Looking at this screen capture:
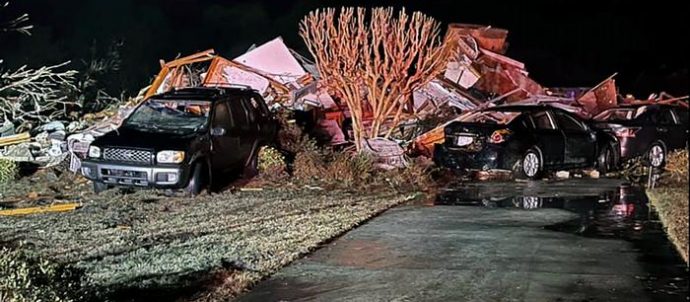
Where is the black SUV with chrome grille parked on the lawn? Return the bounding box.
[81,88,278,195]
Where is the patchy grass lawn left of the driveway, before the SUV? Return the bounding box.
[0,169,413,300]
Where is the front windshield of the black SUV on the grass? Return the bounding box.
[123,99,211,133]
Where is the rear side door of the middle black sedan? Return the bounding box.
[530,110,565,166]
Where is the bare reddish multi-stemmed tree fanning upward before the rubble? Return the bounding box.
[300,8,453,148]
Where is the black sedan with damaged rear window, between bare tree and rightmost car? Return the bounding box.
[434,105,619,179]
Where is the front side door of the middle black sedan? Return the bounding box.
[551,109,597,166]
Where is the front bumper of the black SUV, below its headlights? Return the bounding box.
[80,161,187,188]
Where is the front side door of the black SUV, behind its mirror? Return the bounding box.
[211,101,240,172]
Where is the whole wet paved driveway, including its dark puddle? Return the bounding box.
[239,179,688,301]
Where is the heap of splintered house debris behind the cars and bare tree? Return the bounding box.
[0,24,687,180]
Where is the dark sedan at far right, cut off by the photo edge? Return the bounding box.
[594,104,688,168]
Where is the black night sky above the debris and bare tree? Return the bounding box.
[0,0,690,97]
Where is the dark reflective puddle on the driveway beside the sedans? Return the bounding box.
[434,182,688,301]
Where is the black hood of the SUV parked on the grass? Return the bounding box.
[92,127,199,151]
